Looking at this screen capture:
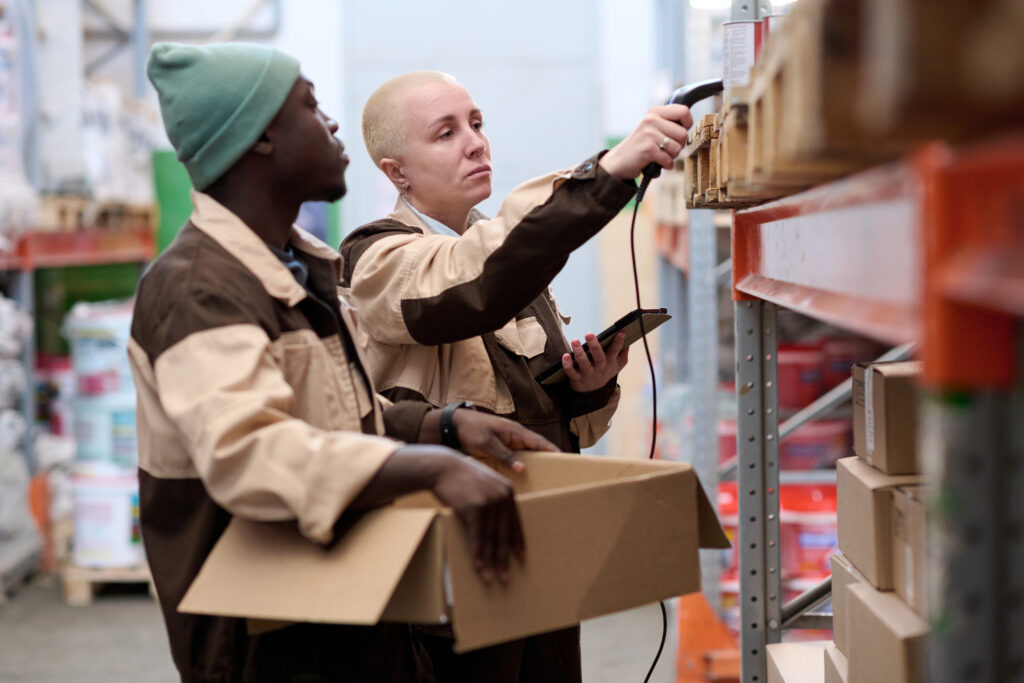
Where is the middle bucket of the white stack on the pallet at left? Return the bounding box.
[72,393,138,467]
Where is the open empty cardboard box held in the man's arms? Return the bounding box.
[179,454,729,651]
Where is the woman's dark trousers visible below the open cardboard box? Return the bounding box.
[417,626,583,683]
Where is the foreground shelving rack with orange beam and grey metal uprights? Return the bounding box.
[732,136,1024,683]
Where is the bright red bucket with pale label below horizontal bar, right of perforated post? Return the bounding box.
[779,483,838,579]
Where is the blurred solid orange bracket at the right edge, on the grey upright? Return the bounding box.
[912,139,1024,390]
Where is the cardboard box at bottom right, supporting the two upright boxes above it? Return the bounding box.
[848,584,929,683]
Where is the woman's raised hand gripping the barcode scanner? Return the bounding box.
[598,104,693,180]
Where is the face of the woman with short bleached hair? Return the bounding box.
[399,82,490,220]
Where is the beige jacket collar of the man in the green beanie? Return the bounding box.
[189,190,341,306]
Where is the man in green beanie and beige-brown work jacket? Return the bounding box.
[129,43,555,683]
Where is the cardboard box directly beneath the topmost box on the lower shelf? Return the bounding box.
[836,458,922,591]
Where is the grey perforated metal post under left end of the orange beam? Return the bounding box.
[735,301,782,683]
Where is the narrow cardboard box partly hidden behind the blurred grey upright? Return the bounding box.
[893,486,928,618]
